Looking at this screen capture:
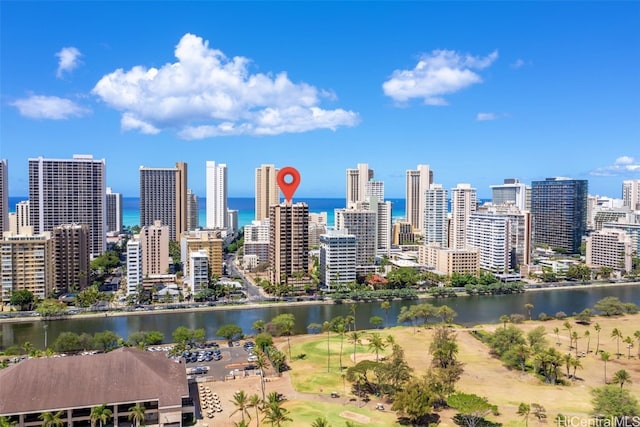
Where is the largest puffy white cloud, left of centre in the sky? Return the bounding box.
[92,34,359,139]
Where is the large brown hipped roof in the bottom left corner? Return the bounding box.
[0,348,189,415]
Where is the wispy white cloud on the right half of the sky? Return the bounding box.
[382,50,498,105]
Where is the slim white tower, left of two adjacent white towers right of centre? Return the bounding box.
[421,184,448,247]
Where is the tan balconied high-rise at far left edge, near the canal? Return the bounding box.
[0,227,54,304]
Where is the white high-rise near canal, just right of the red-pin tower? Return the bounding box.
[320,230,357,292]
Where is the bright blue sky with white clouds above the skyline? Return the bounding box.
[0,1,640,197]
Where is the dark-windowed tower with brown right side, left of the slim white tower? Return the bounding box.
[140,162,187,241]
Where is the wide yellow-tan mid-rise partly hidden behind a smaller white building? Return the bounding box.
[180,230,224,277]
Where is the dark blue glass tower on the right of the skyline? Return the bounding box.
[531,178,588,253]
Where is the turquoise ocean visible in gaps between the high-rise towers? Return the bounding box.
[9,196,405,231]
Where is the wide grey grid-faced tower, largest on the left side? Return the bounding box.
[29,155,107,256]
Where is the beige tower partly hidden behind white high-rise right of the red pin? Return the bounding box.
[335,208,378,267]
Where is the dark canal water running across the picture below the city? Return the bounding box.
[0,285,640,348]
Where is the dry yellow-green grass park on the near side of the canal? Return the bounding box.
[199,315,640,427]
